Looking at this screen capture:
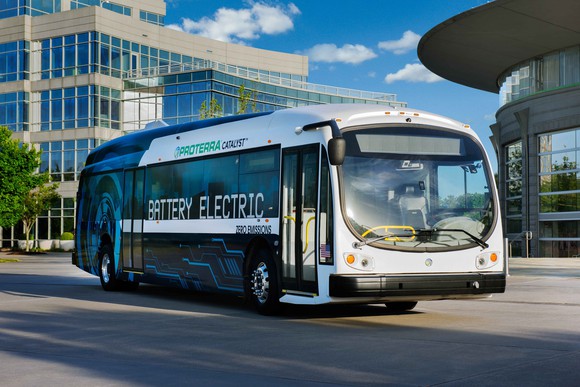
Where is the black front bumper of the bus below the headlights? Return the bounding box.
[329,273,506,297]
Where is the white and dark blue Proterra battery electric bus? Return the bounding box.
[73,104,506,314]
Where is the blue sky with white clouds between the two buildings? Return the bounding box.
[165,0,499,170]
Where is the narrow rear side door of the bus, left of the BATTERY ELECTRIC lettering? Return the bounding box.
[122,168,145,272]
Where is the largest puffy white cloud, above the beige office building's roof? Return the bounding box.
[167,2,300,43]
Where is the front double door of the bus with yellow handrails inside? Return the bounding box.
[281,145,319,296]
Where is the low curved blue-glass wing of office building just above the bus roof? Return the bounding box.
[123,70,401,131]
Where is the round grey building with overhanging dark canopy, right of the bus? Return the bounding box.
[418,0,580,257]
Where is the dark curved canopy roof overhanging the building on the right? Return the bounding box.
[417,0,580,93]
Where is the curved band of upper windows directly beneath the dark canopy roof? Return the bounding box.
[499,46,580,106]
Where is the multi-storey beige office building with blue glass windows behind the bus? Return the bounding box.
[0,0,405,246]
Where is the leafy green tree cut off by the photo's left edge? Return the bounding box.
[0,127,49,227]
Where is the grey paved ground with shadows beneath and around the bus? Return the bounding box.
[0,253,580,386]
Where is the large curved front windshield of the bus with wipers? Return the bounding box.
[341,127,495,251]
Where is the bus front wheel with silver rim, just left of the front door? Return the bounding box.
[246,250,280,316]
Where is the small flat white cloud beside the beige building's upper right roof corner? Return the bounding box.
[302,43,377,64]
